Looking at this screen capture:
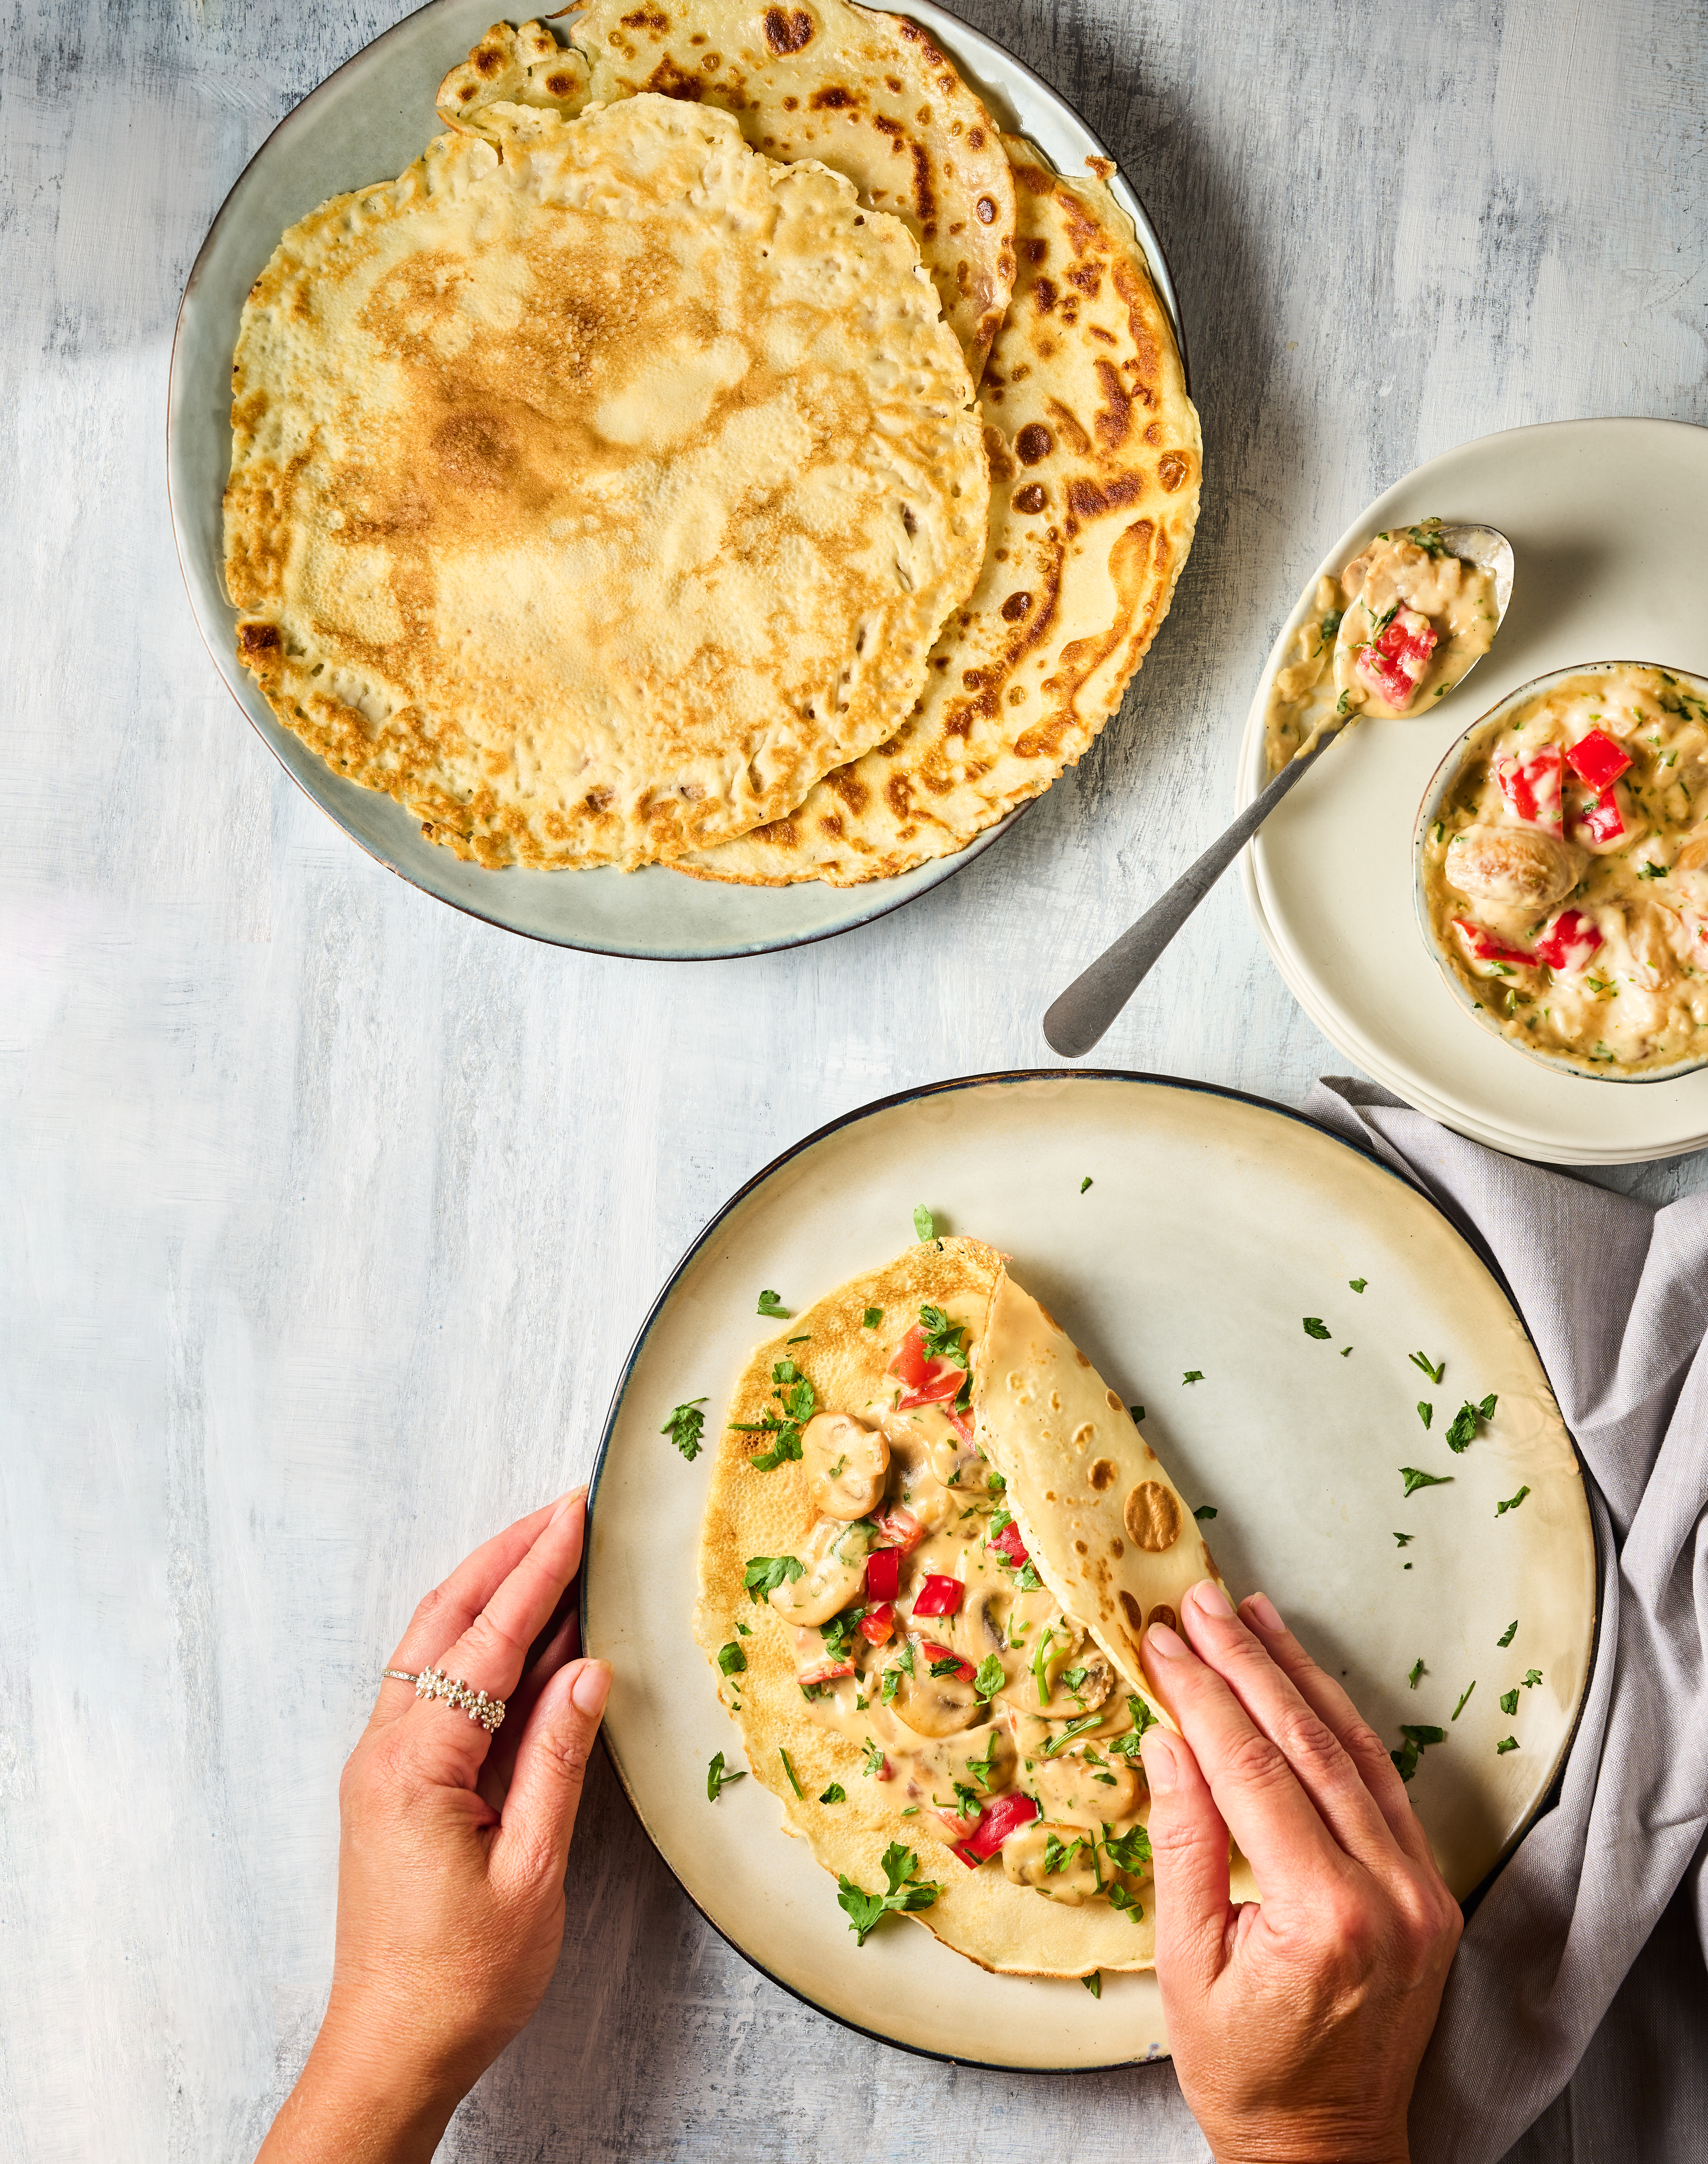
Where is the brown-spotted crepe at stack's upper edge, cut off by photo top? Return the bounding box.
[437,0,1015,383]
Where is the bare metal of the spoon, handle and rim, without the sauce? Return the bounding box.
[1044,526,1513,1060]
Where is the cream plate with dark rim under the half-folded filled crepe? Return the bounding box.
[582,1071,1595,2071]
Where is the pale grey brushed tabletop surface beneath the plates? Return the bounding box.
[0,0,1708,2164]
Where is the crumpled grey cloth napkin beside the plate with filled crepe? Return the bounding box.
[1305,1075,1708,2164]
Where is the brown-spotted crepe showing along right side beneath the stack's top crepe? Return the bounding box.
[677,136,1201,887]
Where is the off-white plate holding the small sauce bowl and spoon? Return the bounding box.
[1240,420,1708,1164]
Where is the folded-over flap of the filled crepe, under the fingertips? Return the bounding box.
[974,1270,1221,1727]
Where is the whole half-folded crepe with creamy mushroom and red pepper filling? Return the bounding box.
[697,1240,1238,1976]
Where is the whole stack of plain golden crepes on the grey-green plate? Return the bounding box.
[225,0,1199,885]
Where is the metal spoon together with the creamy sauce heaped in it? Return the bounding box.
[1044,519,1513,1060]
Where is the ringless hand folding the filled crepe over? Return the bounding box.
[1141,1580,1463,2164]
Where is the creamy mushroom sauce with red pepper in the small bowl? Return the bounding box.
[1424,667,1708,1073]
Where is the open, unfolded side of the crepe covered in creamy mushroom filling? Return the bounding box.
[695,1238,1156,1976]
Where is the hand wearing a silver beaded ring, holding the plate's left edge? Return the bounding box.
[260,1489,610,2164]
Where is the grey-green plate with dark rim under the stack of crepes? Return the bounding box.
[167,0,1186,961]
